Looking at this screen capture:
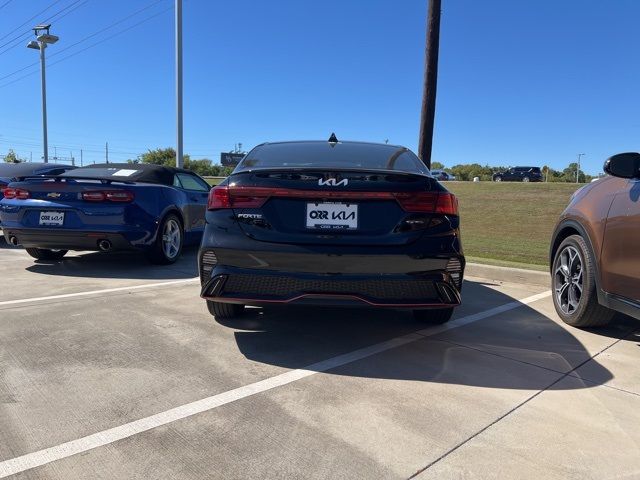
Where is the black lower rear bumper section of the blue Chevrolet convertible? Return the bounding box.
[3,227,135,251]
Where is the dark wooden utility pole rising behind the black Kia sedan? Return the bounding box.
[418,0,441,168]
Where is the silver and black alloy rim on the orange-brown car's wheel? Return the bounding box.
[554,245,584,315]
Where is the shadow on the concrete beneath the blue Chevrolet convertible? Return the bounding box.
[26,247,198,280]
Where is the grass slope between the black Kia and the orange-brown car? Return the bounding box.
[444,182,582,269]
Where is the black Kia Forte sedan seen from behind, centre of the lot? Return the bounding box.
[198,136,465,323]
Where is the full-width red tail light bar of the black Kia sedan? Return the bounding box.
[208,185,458,215]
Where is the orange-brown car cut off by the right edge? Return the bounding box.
[550,153,640,327]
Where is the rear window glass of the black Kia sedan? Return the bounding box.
[235,142,429,175]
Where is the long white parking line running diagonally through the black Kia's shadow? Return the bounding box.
[0,282,551,478]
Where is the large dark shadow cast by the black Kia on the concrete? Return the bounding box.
[218,282,638,390]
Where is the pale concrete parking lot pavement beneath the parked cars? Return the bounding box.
[0,242,640,479]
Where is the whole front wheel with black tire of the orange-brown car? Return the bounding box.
[551,235,615,328]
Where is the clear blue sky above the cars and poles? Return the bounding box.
[0,0,640,173]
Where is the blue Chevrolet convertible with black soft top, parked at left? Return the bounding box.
[0,163,210,264]
